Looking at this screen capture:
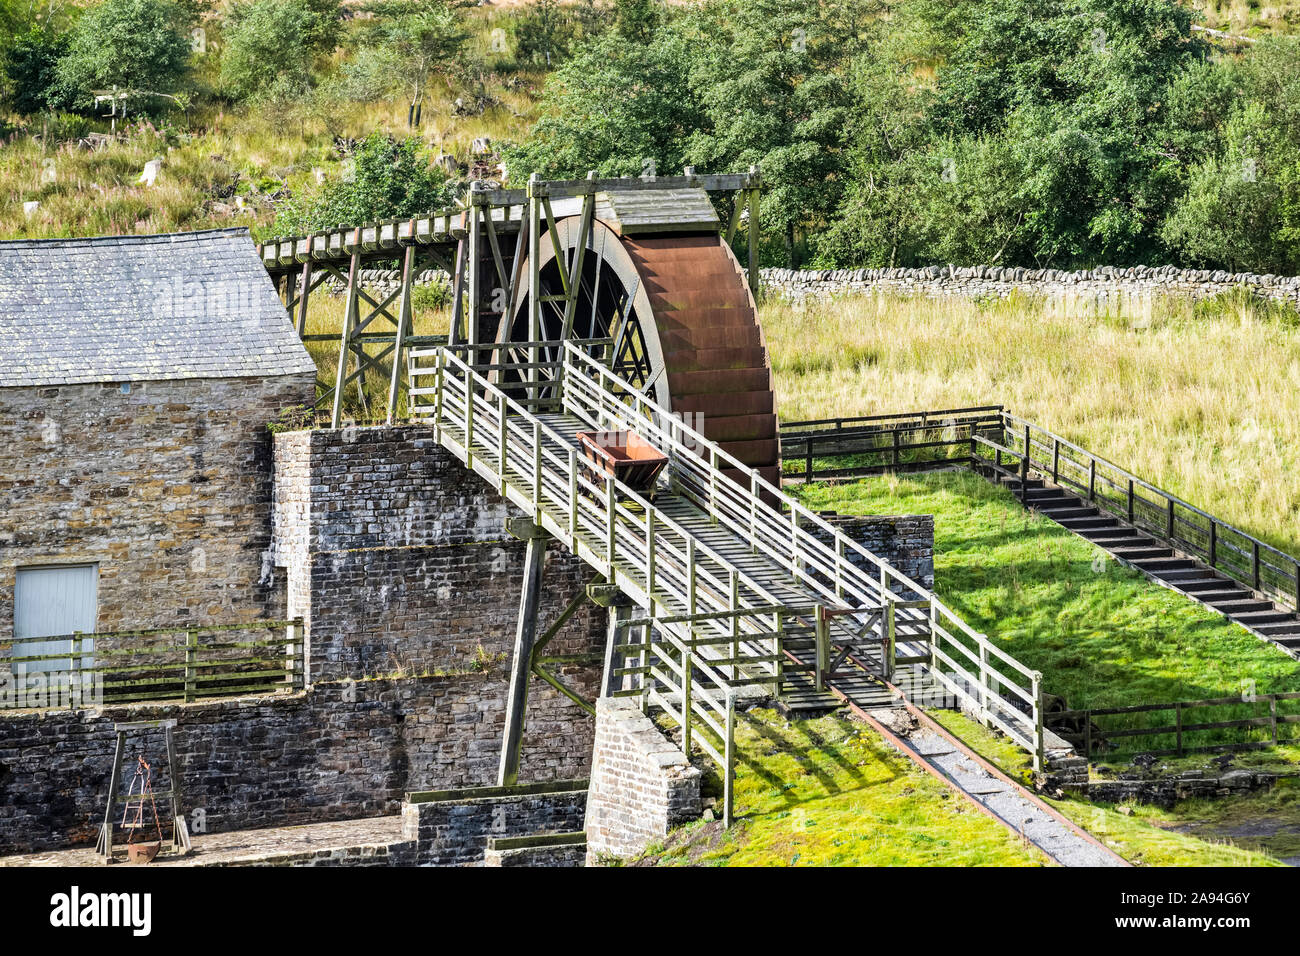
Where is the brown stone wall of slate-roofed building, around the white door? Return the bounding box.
[0,375,313,641]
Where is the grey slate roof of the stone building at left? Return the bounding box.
[0,229,316,388]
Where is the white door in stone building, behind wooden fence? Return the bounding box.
[13,564,99,674]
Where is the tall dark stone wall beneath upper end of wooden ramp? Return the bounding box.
[273,425,605,679]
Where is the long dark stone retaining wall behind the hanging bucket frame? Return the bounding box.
[0,671,595,853]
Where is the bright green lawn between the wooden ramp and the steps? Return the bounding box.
[792,471,1300,708]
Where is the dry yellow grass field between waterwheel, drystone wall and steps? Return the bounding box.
[762,298,1300,554]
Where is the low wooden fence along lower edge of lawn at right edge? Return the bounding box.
[1048,693,1300,758]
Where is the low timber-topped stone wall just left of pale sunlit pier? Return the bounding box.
[402,780,586,866]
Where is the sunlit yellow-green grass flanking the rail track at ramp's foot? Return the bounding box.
[634,710,1279,866]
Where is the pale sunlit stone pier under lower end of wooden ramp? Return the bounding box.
[584,697,703,864]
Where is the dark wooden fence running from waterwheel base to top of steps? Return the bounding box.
[781,405,1002,483]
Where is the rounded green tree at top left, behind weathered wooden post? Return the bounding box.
[57,0,194,112]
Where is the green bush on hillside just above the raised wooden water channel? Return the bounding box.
[270,133,456,235]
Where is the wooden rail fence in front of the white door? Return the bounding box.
[0,618,304,710]
